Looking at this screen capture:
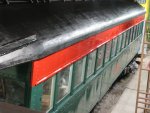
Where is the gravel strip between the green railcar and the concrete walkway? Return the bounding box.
[91,74,133,113]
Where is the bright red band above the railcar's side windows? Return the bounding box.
[31,15,144,86]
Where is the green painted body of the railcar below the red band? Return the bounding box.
[0,22,144,113]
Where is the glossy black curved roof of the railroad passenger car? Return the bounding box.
[0,0,145,69]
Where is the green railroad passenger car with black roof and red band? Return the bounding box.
[0,0,145,113]
